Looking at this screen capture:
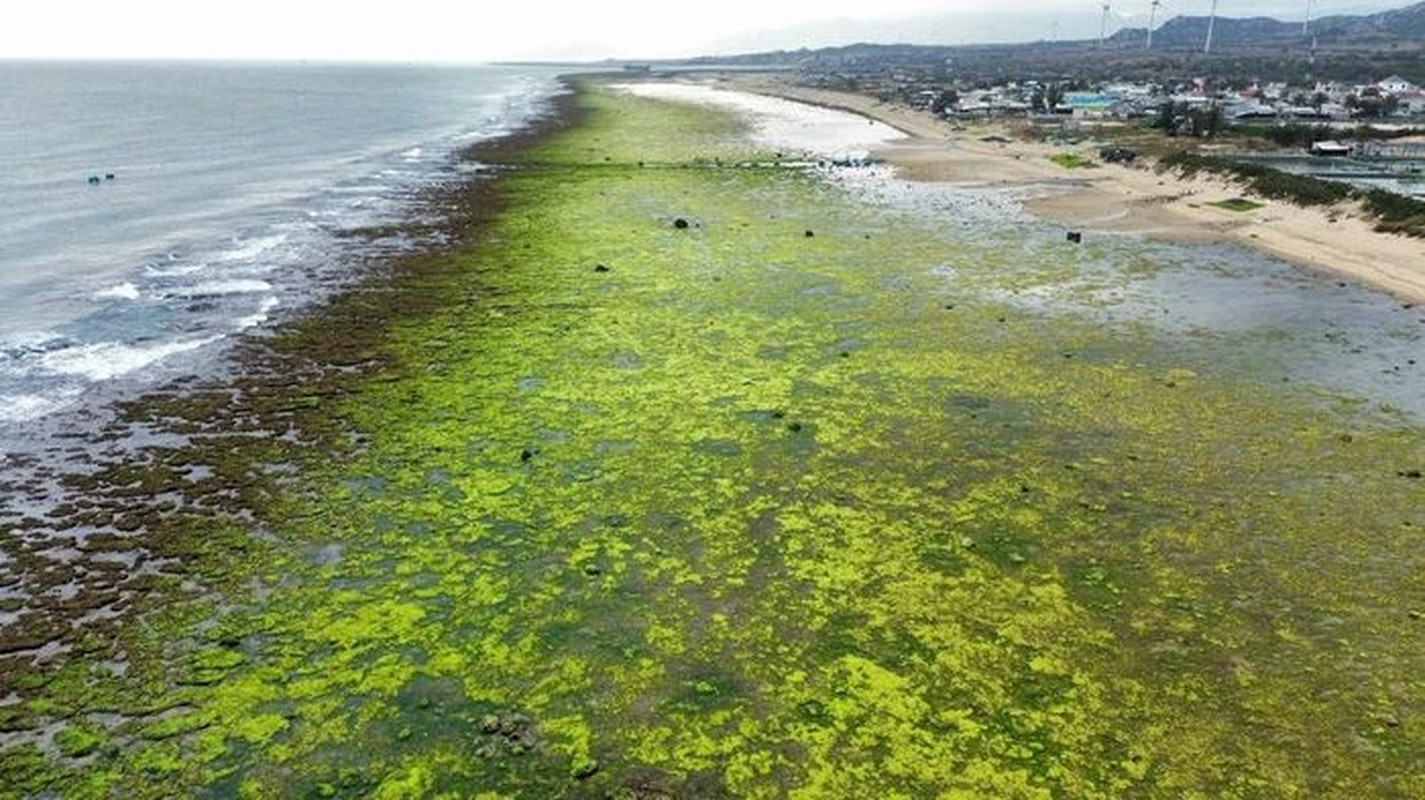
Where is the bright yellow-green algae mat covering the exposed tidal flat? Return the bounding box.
[0,79,1425,799]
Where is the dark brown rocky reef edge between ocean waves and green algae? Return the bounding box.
[0,81,581,664]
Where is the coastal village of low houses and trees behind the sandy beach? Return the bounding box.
[795,60,1425,185]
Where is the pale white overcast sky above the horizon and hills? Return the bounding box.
[0,0,1409,61]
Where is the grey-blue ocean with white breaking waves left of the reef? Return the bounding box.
[0,61,559,442]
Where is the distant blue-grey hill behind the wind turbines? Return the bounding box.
[1110,1,1425,47]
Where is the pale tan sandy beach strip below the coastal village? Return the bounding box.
[727,76,1425,301]
